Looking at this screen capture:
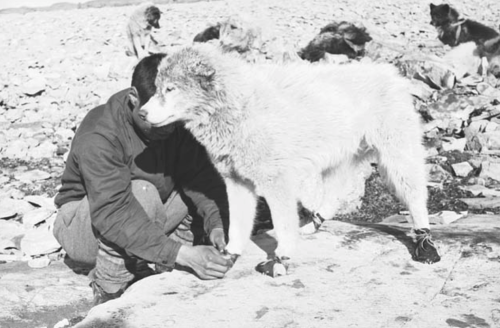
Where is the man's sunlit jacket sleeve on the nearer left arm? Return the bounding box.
[78,134,184,268]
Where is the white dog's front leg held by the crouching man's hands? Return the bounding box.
[225,179,257,255]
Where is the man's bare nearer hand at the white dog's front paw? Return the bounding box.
[176,245,233,280]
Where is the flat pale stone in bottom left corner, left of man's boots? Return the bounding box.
[0,260,92,328]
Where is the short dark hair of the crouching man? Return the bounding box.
[132,53,166,106]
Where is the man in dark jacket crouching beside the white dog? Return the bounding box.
[54,54,232,305]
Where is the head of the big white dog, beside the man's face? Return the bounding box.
[142,47,218,127]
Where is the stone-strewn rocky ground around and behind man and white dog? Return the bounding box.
[0,0,500,327]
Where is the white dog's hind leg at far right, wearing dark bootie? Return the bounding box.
[375,122,441,263]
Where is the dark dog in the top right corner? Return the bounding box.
[430,3,499,47]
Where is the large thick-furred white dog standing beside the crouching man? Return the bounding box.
[143,45,429,256]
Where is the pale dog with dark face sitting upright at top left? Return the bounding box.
[127,2,161,59]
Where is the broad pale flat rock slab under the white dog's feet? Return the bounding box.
[75,216,500,328]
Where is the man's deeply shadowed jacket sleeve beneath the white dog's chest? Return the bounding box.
[175,128,229,235]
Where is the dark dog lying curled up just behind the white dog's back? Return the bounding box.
[298,21,372,62]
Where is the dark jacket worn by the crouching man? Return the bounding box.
[55,88,228,267]
